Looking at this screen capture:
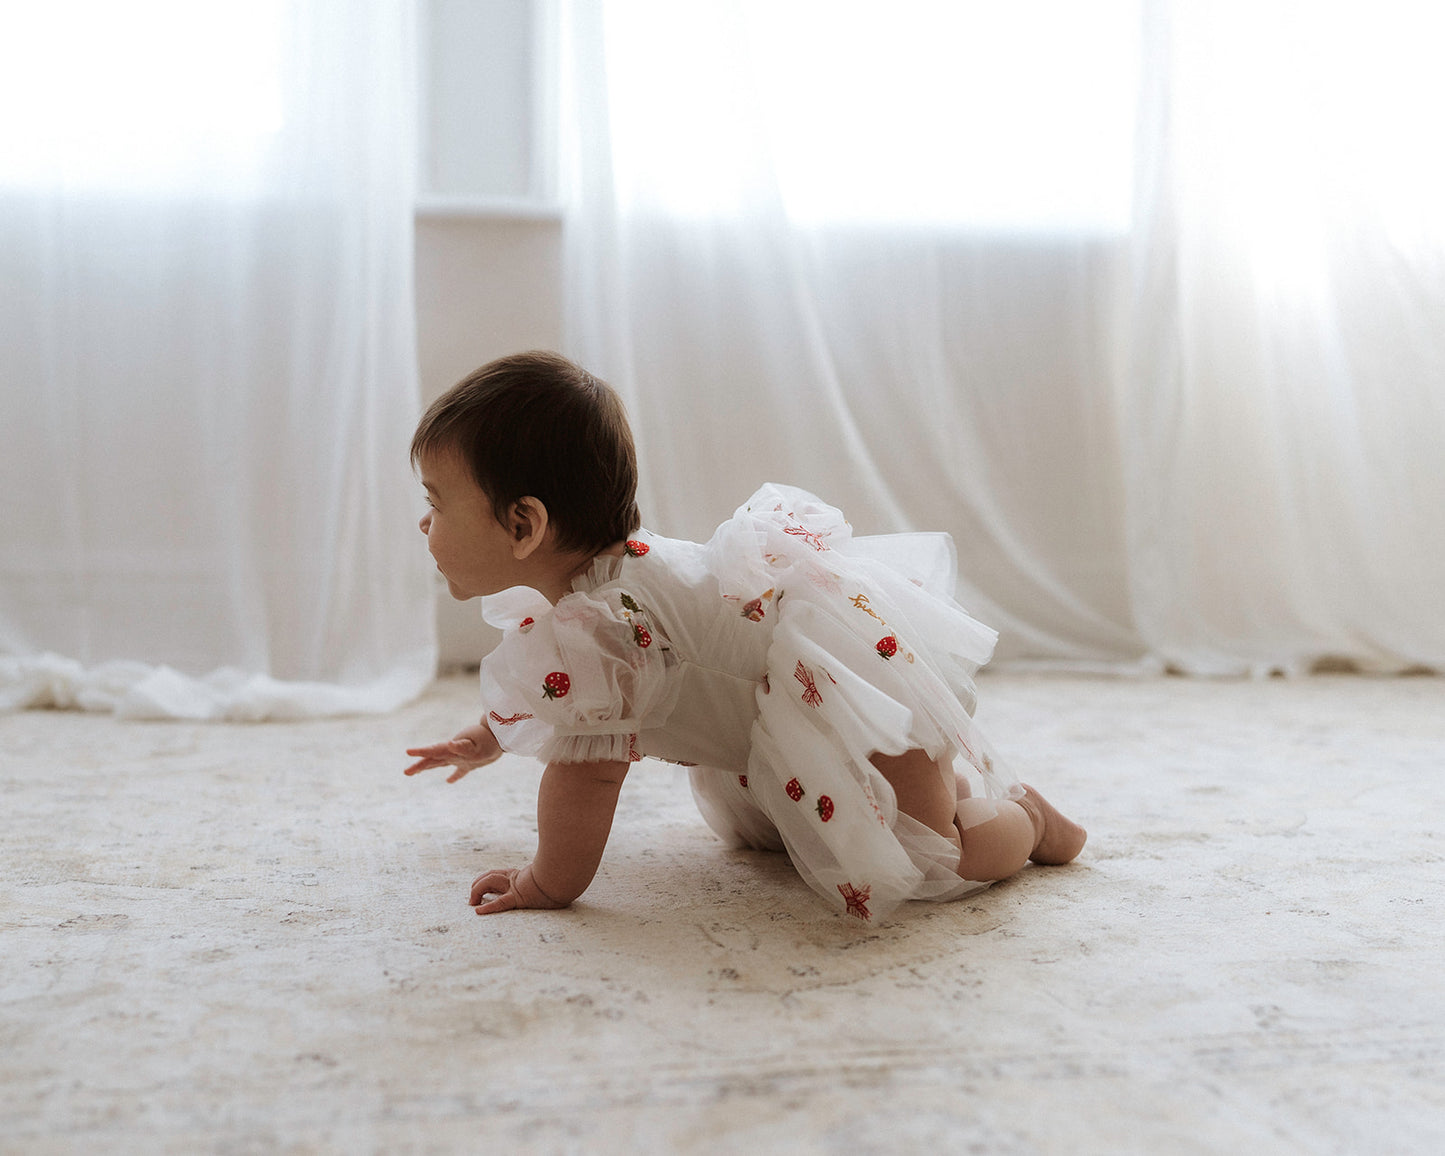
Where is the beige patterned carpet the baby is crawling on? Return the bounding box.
[0,675,1445,1153]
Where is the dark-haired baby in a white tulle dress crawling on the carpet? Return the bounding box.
[406,353,1085,920]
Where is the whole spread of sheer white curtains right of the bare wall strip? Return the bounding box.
[564,0,1445,672]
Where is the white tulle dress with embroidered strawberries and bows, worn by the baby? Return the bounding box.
[481,484,1022,920]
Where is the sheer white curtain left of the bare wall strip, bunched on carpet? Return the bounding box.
[0,0,435,718]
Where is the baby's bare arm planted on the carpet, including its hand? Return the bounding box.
[468,762,627,915]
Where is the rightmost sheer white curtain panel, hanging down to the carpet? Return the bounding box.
[1118,1,1445,672]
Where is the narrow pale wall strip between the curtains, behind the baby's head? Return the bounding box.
[416,0,562,669]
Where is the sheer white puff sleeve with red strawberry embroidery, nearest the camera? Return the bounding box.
[481,587,681,763]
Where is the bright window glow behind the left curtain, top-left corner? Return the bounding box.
[0,0,286,192]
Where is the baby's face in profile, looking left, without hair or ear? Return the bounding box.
[418,449,519,600]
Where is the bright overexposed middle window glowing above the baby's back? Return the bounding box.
[607,0,1140,231]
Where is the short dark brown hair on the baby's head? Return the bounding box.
[412,350,642,552]
